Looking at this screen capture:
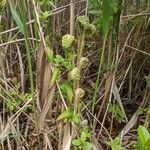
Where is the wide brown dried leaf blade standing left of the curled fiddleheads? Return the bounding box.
[37,42,55,131]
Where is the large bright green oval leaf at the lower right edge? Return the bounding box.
[138,125,150,145]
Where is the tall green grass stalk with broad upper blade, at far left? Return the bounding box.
[9,0,41,147]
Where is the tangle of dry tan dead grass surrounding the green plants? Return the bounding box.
[0,0,150,150]
